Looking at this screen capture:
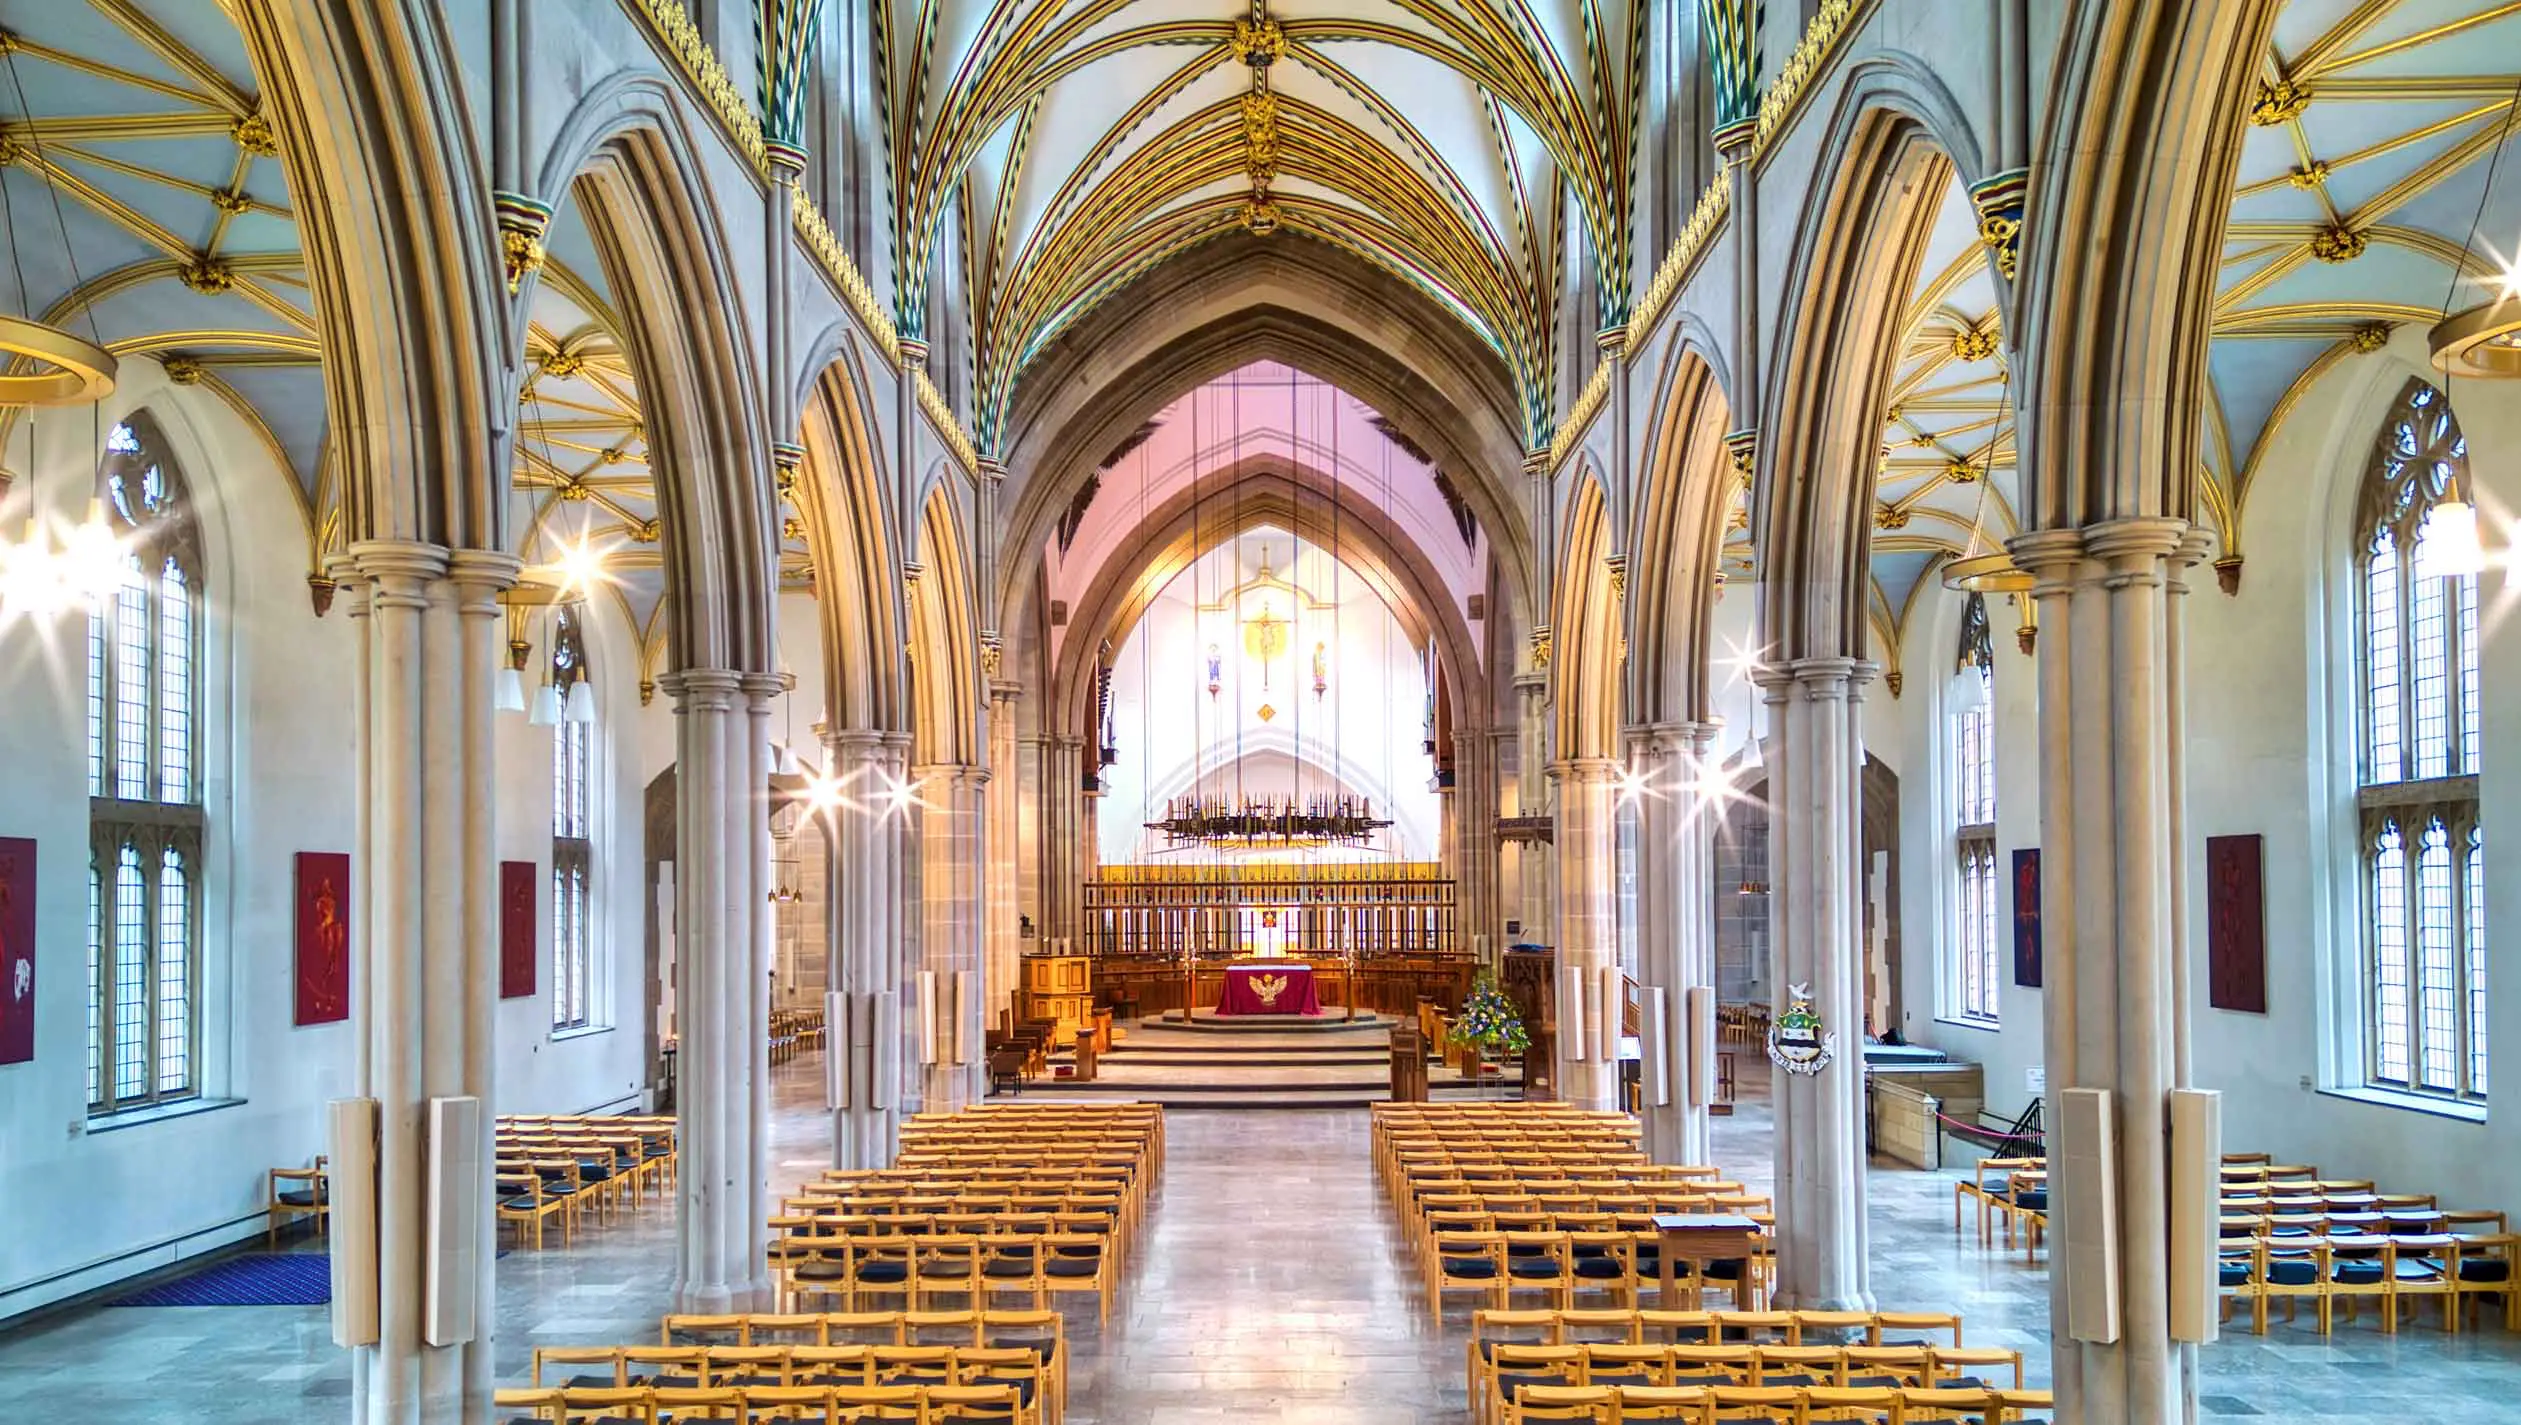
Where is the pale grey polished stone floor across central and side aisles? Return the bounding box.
[14,1057,2521,1425]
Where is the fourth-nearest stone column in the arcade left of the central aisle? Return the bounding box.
[908,762,988,1112]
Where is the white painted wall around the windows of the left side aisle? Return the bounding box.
[0,358,671,1317]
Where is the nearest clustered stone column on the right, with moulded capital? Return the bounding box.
[2012,517,2201,1422]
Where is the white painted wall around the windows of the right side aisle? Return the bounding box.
[1898,330,2521,1211]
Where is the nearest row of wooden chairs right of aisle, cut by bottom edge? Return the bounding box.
[1503,1385,2055,1425]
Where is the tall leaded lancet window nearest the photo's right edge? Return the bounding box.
[2355,381,2486,1100]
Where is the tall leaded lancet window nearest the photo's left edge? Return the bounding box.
[88,416,202,1115]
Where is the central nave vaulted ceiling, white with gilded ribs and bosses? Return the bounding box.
[877,0,1644,449]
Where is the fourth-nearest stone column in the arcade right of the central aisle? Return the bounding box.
[1550,757,1618,1110]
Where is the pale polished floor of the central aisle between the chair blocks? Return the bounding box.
[1069,1110,1467,1425]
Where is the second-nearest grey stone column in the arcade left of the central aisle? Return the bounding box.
[658,668,779,1312]
